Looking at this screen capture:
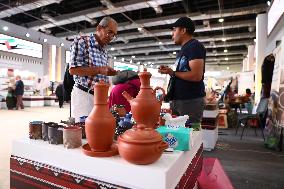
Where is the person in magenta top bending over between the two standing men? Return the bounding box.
[108,70,141,112]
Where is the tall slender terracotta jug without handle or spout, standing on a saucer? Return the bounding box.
[85,81,115,152]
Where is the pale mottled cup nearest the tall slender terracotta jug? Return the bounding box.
[63,126,82,149]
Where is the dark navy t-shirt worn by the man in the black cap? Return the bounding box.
[174,39,206,100]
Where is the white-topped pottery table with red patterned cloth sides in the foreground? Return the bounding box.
[10,131,203,189]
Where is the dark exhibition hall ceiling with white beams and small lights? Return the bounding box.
[0,0,268,67]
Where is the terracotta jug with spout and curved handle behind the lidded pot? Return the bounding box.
[122,68,165,128]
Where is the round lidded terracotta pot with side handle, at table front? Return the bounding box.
[118,124,168,165]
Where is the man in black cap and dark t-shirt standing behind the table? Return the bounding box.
[159,17,206,123]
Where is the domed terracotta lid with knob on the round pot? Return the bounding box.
[120,124,162,143]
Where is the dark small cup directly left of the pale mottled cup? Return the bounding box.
[48,125,63,144]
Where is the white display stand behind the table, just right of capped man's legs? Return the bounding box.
[201,110,218,151]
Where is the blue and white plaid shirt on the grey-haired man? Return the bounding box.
[69,34,109,89]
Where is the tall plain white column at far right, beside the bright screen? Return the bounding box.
[255,14,267,102]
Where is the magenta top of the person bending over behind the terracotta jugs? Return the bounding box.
[108,71,141,112]
